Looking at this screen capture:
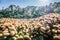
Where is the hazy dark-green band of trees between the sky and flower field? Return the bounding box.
[0,2,60,18]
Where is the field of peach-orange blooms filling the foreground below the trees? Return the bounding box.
[0,13,60,40]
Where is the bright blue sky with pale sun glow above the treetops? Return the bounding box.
[0,0,60,8]
